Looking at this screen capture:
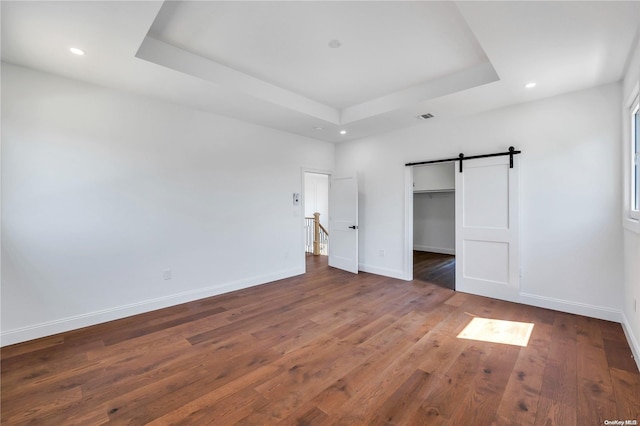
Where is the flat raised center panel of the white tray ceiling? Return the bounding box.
[150,2,487,109]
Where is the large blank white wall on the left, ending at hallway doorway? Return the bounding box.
[2,64,334,345]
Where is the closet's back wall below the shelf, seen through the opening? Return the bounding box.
[413,191,456,254]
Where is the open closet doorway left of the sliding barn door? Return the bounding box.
[412,163,456,290]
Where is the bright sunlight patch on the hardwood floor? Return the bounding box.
[458,317,533,346]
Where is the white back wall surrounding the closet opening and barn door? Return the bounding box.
[336,84,623,320]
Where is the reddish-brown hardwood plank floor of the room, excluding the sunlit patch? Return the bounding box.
[1,256,640,426]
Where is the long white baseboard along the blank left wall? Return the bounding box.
[0,267,304,346]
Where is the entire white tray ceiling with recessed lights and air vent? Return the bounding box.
[1,1,640,142]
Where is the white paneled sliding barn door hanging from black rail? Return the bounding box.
[456,156,520,301]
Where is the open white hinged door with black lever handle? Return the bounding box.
[329,176,358,274]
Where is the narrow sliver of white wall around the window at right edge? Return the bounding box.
[619,40,640,368]
